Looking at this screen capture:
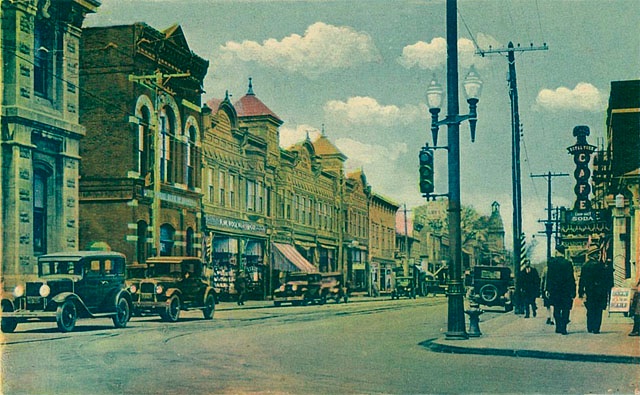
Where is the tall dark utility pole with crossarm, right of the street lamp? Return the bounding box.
[476,42,549,275]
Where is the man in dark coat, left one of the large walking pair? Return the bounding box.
[546,256,576,335]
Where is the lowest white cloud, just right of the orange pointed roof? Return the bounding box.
[336,138,408,169]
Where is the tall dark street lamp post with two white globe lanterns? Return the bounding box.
[427,0,482,340]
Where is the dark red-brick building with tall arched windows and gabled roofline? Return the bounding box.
[80,23,209,263]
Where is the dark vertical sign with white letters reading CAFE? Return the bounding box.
[567,126,596,211]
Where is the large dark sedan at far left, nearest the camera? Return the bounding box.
[2,251,131,332]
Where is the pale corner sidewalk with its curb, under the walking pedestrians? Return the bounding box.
[423,299,640,364]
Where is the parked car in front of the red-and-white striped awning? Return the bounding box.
[273,272,323,306]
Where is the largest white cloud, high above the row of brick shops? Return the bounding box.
[219,22,380,77]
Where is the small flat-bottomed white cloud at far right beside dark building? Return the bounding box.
[536,82,605,112]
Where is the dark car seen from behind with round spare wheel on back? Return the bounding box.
[468,266,514,311]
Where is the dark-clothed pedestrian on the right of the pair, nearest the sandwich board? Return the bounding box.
[578,257,613,333]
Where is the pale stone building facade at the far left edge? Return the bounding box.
[0,0,100,287]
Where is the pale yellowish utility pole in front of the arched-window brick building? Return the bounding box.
[129,70,191,256]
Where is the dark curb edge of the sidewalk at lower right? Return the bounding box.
[419,339,640,364]
